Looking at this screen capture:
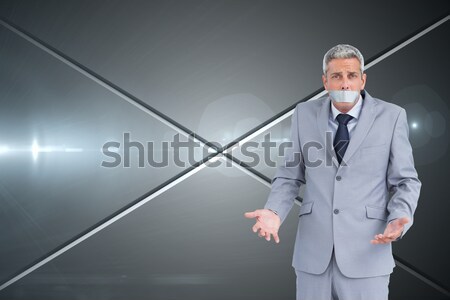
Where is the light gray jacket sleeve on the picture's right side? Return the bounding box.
[387,108,422,238]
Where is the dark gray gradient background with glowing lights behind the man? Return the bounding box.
[0,0,450,299]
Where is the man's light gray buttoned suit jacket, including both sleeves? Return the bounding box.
[265,91,421,278]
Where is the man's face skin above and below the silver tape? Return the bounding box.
[322,58,366,113]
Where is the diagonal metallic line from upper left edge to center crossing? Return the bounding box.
[0,18,217,150]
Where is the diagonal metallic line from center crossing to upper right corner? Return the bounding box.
[219,13,450,152]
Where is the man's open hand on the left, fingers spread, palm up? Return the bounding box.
[244,209,281,243]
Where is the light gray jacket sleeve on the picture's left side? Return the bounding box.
[264,104,305,222]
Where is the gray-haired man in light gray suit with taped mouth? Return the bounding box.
[245,44,421,300]
